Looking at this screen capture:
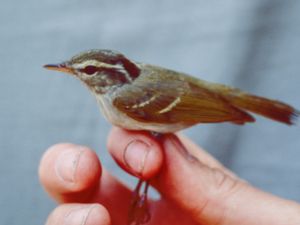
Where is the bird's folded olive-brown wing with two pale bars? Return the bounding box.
[113,80,254,125]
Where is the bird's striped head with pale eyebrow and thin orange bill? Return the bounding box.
[44,50,140,94]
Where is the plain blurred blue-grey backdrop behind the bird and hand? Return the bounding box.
[0,0,300,225]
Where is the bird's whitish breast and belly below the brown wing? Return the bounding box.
[97,97,188,133]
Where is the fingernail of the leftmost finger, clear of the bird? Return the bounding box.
[55,146,84,183]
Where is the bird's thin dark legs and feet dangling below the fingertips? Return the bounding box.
[128,179,150,225]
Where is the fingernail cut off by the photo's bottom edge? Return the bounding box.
[64,205,95,225]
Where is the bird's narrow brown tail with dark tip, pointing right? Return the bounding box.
[230,93,300,125]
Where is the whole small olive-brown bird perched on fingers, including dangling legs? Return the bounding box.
[44,49,300,224]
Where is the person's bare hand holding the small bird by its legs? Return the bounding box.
[39,128,300,225]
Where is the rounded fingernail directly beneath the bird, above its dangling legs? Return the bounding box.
[123,140,150,175]
